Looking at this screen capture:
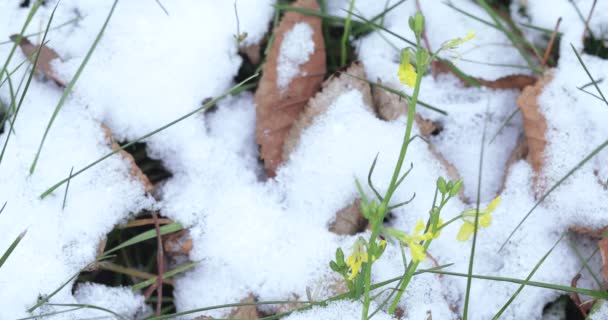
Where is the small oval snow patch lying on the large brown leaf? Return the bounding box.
[277,22,315,90]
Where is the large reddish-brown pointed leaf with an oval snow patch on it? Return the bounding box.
[255,0,326,177]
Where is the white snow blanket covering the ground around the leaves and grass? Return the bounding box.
[0,0,608,320]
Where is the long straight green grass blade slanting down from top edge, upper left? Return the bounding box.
[30,0,118,174]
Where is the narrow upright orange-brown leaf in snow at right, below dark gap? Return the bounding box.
[517,73,551,187]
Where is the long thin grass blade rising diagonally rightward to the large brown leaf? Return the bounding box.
[40,73,258,199]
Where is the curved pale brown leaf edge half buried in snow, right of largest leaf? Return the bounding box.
[283,62,373,159]
